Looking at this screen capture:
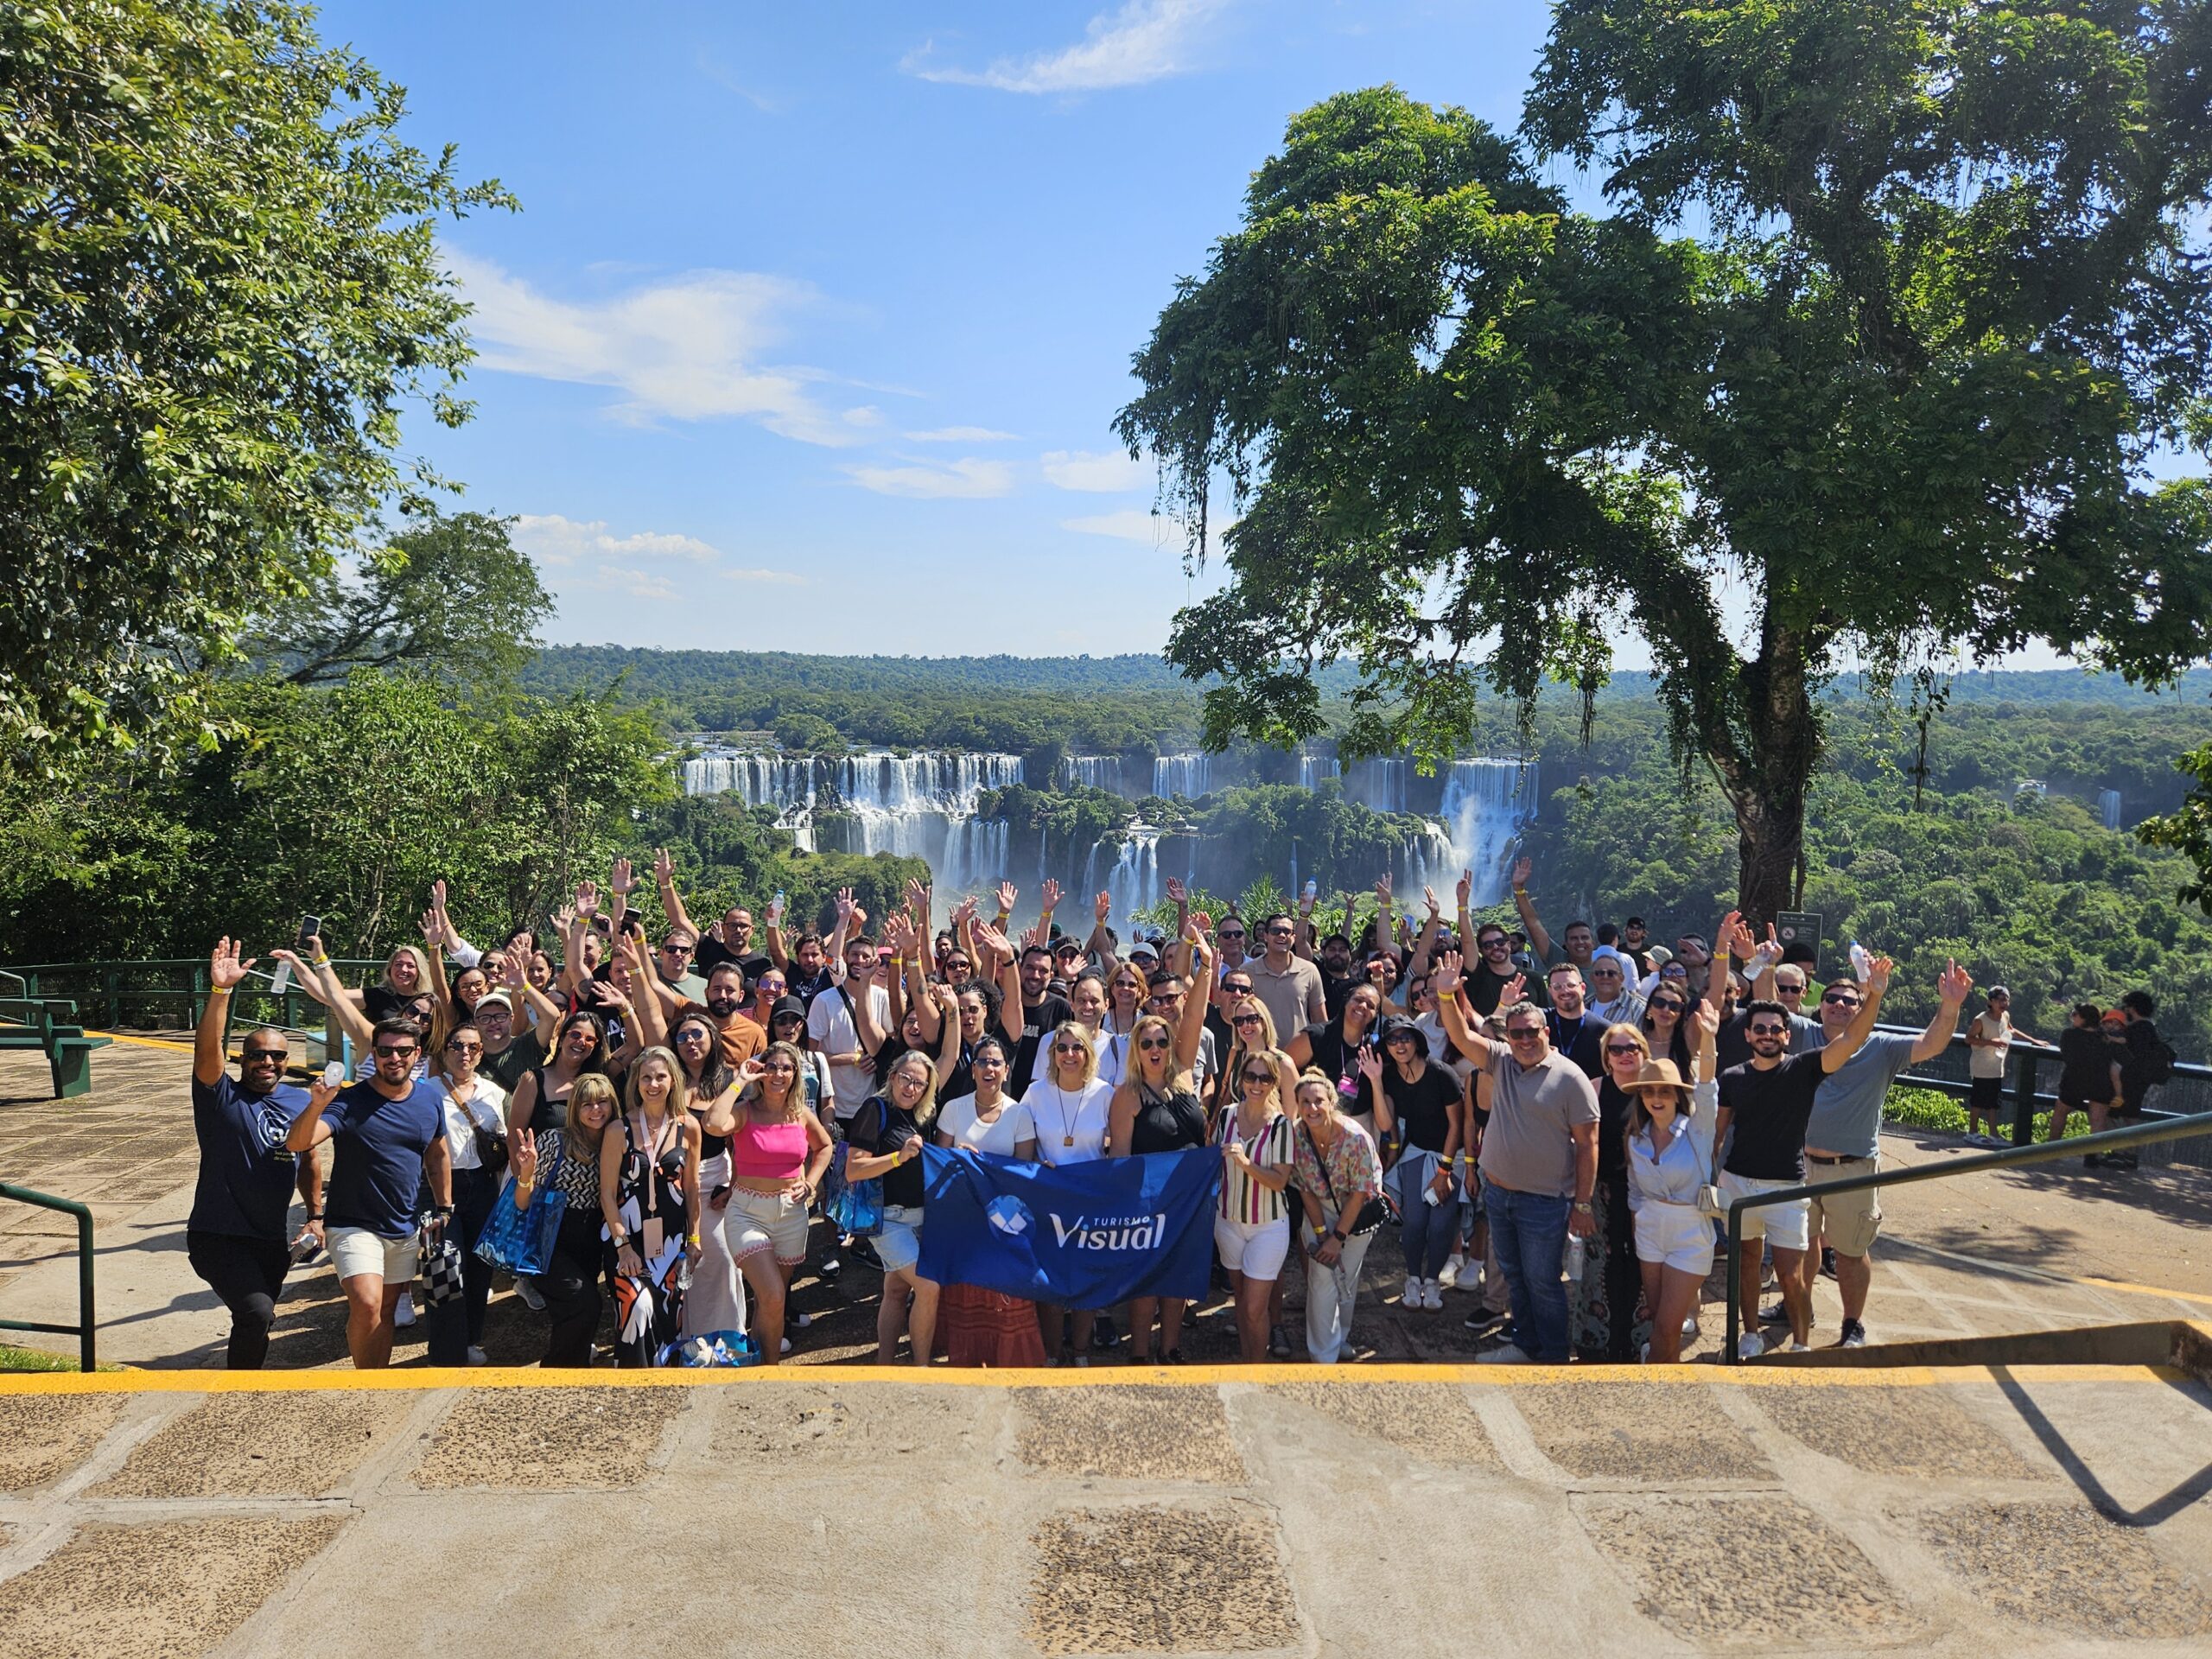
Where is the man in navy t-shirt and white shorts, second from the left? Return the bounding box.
[285,1020,454,1371]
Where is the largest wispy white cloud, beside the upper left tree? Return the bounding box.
[447,250,872,445]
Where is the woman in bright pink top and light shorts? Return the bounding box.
[706,1042,830,1365]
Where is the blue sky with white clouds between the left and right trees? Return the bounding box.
[323,0,1544,655]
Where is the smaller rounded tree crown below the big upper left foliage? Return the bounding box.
[248,513,553,688]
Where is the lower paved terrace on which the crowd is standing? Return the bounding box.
[0,1042,2212,1370]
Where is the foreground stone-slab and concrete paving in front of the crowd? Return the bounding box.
[0,1365,2212,1659]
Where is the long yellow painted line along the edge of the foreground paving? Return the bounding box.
[0,1365,2188,1394]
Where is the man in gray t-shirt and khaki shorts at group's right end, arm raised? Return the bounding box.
[1802,963,1974,1347]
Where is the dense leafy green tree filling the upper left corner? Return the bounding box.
[0,0,506,772]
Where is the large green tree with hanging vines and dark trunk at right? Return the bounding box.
[1117,0,2212,913]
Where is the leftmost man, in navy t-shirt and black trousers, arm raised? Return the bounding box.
[183,938,323,1371]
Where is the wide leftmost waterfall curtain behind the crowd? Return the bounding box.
[683,750,1022,896]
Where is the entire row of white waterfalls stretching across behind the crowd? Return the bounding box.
[683,746,1540,925]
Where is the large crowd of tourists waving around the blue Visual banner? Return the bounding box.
[188,854,2154,1367]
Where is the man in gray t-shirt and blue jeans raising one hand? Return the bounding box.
[1429,951,1597,1365]
